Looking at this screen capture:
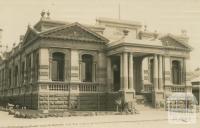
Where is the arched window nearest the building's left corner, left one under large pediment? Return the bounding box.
[52,52,65,81]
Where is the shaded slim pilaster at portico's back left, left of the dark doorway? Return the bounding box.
[107,57,112,92]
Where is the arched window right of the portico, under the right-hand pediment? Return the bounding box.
[172,60,181,84]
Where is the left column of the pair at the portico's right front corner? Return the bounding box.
[153,55,158,91]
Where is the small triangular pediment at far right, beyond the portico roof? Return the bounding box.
[160,36,192,50]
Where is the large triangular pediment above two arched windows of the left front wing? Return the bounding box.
[41,23,108,42]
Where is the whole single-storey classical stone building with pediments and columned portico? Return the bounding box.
[0,13,192,110]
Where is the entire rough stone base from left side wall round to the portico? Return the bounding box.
[0,92,119,111]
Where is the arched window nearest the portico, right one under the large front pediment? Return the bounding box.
[81,54,93,82]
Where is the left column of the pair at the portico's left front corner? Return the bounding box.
[123,52,128,90]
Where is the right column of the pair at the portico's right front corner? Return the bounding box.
[158,55,163,91]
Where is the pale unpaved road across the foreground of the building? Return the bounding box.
[0,110,200,128]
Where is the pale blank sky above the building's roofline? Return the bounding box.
[0,0,200,69]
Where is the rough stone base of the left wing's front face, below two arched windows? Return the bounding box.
[39,93,107,111]
